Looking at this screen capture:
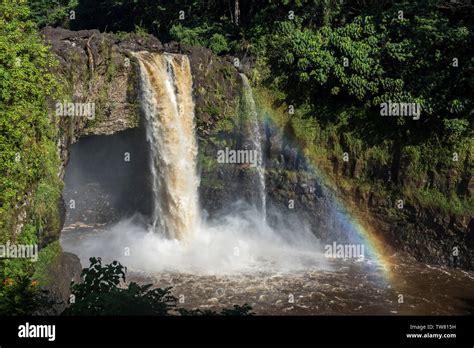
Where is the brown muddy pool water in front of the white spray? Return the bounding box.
[61,225,474,315]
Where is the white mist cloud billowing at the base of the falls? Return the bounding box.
[62,201,328,275]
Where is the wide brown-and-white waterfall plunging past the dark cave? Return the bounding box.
[134,52,200,240]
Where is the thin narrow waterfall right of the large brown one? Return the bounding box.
[240,74,267,220]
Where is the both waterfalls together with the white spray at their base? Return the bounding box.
[64,52,324,275]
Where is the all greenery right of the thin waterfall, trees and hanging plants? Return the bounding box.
[253,0,474,214]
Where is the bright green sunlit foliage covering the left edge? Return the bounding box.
[0,1,62,314]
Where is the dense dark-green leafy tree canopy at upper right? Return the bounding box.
[266,0,473,140]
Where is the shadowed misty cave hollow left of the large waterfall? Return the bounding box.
[63,128,152,227]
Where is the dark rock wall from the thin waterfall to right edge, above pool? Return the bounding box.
[260,119,474,269]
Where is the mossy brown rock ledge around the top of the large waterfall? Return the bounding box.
[41,27,240,173]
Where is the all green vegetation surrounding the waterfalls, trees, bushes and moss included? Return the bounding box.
[0,0,474,315]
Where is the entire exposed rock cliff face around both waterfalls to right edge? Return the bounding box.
[42,27,474,268]
